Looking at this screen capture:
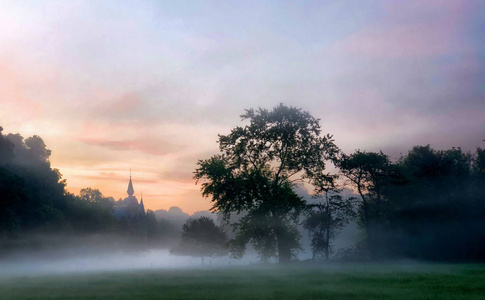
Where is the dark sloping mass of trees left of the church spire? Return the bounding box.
[0,127,121,238]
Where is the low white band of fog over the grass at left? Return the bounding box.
[0,239,259,277]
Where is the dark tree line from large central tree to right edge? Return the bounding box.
[194,104,485,263]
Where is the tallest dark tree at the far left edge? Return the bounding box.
[0,128,66,230]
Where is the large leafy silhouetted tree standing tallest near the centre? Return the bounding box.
[195,104,338,262]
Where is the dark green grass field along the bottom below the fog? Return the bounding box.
[0,264,485,300]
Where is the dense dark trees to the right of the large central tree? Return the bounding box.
[339,145,485,261]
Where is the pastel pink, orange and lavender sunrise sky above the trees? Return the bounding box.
[0,0,485,213]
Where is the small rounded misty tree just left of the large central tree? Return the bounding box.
[170,217,227,264]
